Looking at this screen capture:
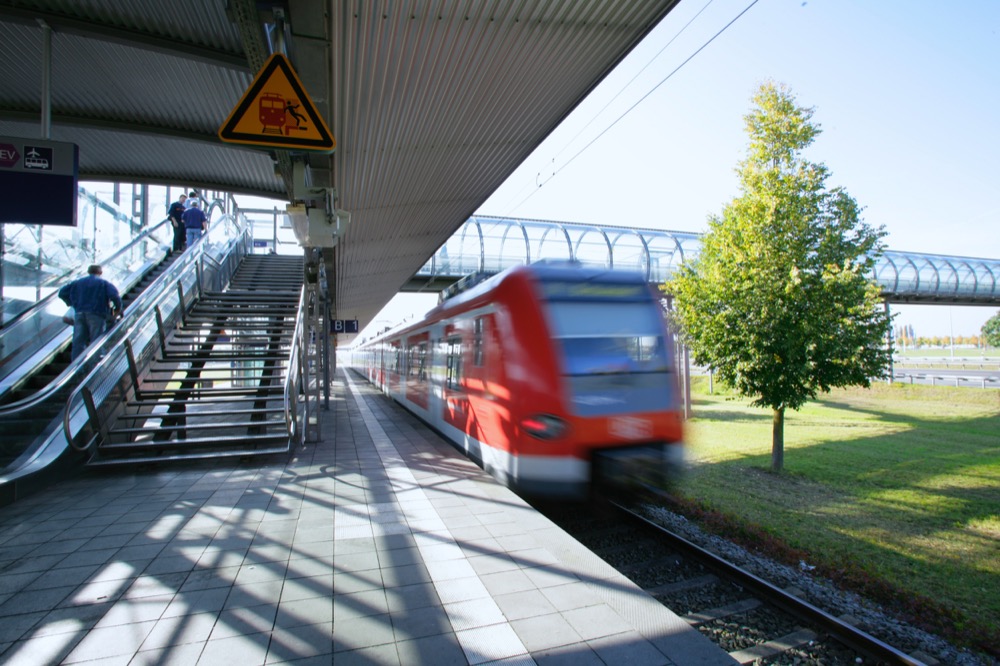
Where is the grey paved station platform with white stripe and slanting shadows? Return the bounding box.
[0,371,735,666]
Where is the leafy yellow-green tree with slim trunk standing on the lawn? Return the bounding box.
[666,82,891,471]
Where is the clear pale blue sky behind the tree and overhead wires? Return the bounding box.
[376,0,1000,335]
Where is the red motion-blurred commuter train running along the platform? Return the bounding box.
[352,263,683,499]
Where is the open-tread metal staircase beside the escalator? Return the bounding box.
[84,255,303,466]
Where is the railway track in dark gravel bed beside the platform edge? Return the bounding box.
[538,502,937,666]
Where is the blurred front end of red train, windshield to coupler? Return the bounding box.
[521,267,683,495]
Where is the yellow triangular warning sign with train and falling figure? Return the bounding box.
[219,53,337,152]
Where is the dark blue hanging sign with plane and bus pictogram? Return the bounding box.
[0,136,80,227]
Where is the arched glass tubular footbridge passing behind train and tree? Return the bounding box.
[403,216,1000,305]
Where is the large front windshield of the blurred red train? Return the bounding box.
[548,300,671,416]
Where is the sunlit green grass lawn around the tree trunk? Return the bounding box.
[680,379,1000,642]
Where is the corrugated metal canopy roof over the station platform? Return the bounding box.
[0,0,678,338]
